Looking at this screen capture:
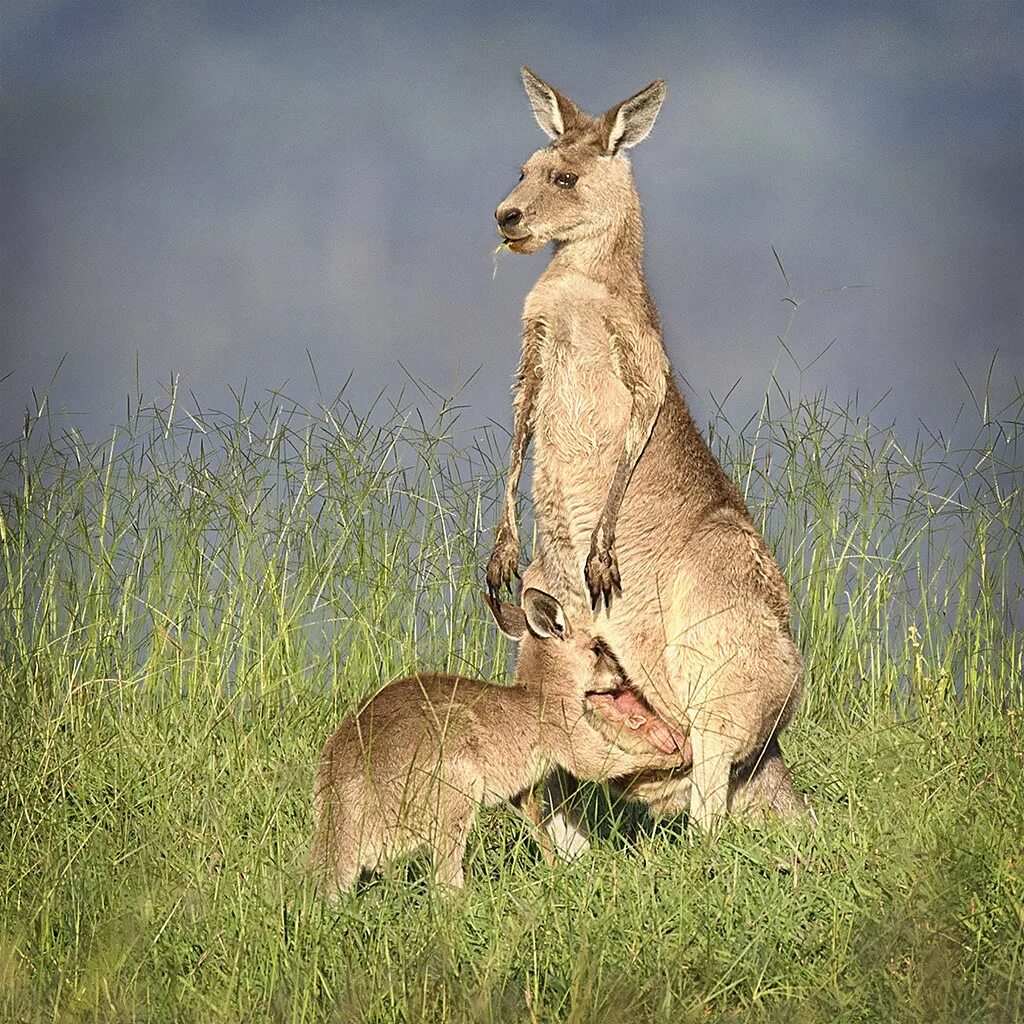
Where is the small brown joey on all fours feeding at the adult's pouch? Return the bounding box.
[310,589,690,897]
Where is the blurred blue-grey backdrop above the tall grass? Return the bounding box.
[0,0,1024,440]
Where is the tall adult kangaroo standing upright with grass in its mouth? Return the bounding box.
[487,68,803,827]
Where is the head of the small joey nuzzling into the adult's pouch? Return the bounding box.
[483,587,623,695]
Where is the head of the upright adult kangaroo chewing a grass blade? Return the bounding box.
[495,68,665,253]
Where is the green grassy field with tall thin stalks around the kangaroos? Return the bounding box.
[0,378,1024,1024]
